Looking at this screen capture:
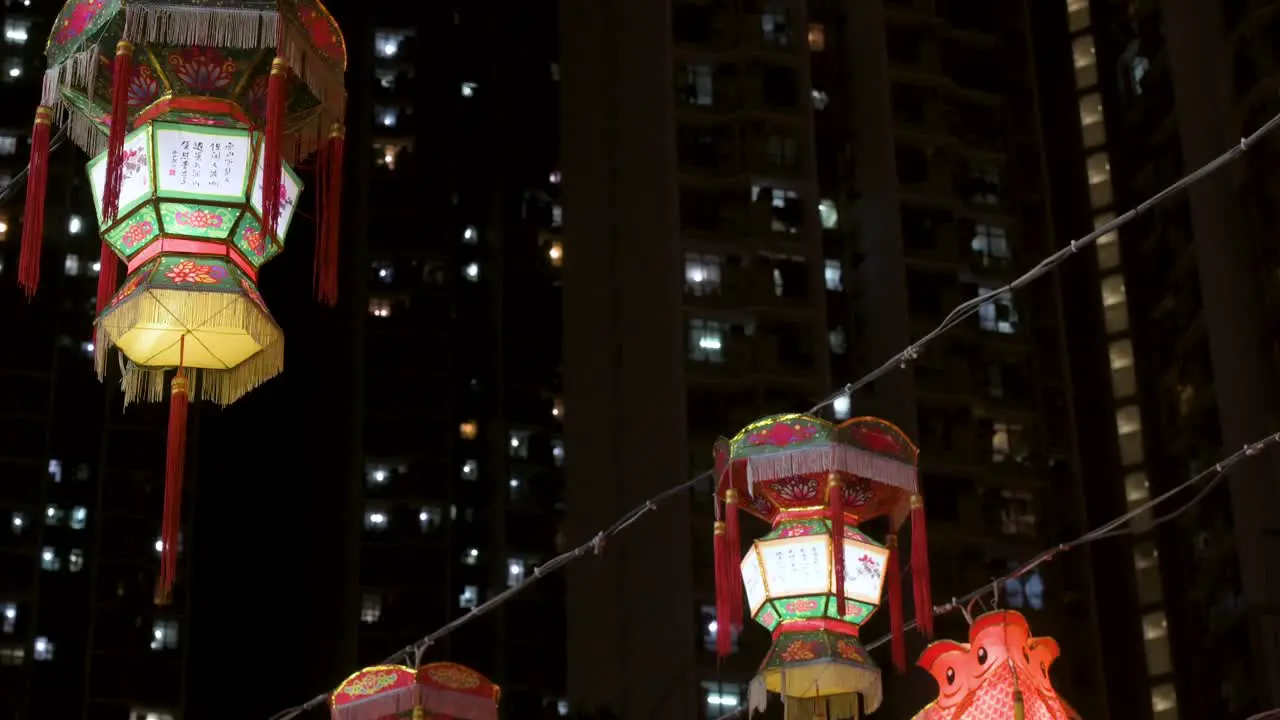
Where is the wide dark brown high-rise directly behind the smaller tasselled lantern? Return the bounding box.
[561,0,1107,717]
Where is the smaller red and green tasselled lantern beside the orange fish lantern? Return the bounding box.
[714,415,933,720]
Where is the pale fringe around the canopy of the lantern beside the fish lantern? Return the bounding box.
[744,445,918,493]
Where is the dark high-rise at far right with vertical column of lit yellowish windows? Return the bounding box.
[1033,0,1280,720]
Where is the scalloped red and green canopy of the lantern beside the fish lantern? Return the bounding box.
[714,414,919,524]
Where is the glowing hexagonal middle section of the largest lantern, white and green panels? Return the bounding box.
[88,122,302,271]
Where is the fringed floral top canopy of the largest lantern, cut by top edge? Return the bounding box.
[44,0,347,160]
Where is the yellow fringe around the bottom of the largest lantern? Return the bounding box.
[93,290,284,406]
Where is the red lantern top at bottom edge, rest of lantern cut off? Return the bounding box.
[329,662,502,720]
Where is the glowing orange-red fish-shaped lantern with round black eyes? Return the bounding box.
[914,610,1080,720]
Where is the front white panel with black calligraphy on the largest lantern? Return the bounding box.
[156,126,252,196]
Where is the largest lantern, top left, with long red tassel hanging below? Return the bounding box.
[19,0,347,602]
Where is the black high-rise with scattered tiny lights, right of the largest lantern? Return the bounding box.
[348,3,566,717]
